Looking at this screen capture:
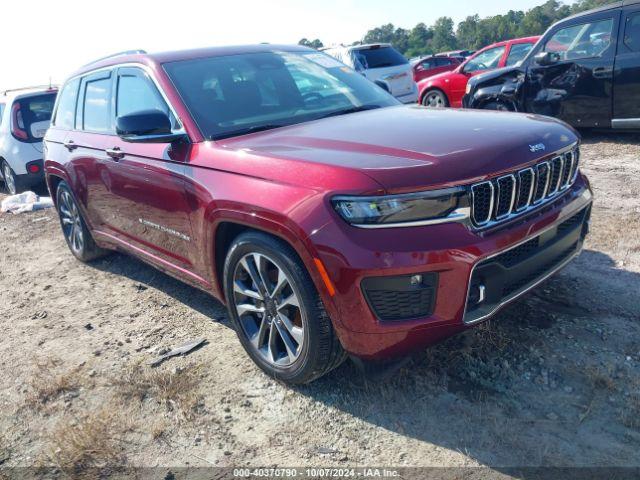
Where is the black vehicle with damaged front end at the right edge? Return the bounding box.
[464,0,640,129]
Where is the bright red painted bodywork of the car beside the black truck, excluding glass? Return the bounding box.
[418,37,540,108]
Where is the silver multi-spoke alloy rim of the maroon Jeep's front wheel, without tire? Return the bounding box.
[232,252,305,367]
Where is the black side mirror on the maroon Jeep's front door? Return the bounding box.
[116,110,185,143]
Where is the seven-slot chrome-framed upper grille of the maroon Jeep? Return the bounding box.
[471,147,580,227]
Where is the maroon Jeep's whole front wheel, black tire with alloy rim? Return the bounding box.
[223,232,346,384]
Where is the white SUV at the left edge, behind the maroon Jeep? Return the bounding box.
[0,87,58,195]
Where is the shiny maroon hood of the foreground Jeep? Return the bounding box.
[218,105,578,192]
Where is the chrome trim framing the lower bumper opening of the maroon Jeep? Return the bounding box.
[462,188,593,325]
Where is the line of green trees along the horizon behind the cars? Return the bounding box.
[298,0,615,58]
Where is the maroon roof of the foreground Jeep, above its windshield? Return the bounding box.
[72,43,316,76]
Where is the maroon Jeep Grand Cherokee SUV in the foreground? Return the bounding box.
[45,45,591,383]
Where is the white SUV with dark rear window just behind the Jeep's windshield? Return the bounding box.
[322,43,418,103]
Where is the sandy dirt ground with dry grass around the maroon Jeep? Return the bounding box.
[0,133,640,476]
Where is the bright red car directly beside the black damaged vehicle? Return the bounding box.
[418,37,540,108]
